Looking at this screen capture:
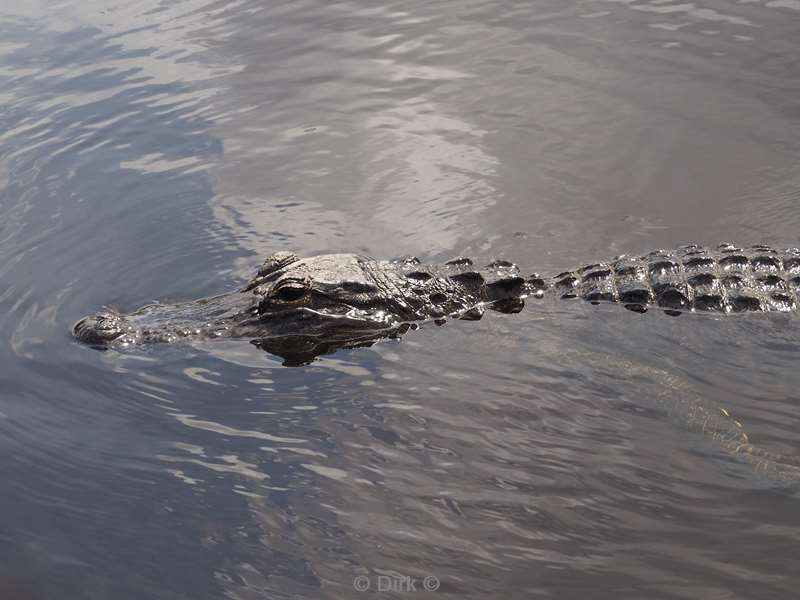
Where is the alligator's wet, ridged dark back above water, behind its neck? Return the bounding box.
[531,244,800,313]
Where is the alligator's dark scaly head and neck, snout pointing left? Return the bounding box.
[74,252,525,364]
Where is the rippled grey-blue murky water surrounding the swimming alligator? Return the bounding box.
[0,0,800,600]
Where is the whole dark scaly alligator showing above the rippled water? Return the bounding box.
[73,243,800,365]
